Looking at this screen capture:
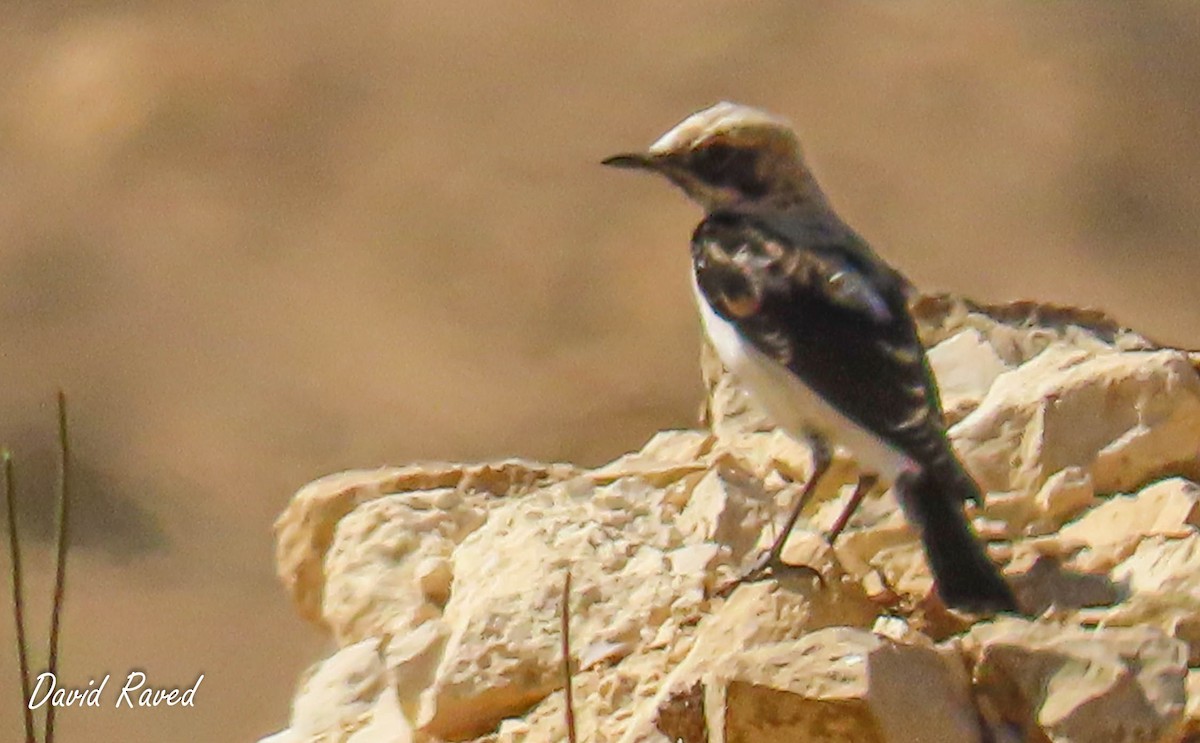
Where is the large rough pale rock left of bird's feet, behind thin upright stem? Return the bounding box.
[415,477,708,739]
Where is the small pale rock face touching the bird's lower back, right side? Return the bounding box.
[929,328,1008,423]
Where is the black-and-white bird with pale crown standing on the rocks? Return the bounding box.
[602,102,1018,613]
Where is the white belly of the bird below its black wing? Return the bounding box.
[692,278,908,484]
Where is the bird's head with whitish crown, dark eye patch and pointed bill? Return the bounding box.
[604,102,816,211]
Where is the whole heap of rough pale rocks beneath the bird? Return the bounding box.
[264,296,1200,743]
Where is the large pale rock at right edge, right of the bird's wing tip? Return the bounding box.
[950,344,1200,493]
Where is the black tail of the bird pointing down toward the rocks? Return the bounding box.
[895,462,1018,613]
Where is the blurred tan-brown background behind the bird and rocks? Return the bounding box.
[0,0,1200,743]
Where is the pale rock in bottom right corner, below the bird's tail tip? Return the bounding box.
[964,618,1187,743]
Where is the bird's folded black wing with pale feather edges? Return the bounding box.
[692,212,958,469]
